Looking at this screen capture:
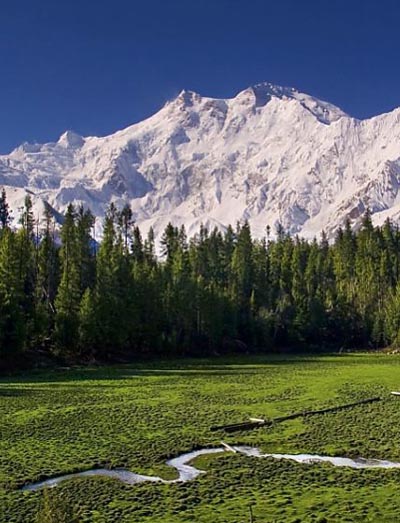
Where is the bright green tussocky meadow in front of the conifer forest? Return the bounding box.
[0,355,400,523]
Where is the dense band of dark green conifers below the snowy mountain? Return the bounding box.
[0,186,400,361]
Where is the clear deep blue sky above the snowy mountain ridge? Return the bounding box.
[0,0,400,153]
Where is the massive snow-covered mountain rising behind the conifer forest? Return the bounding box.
[0,83,400,242]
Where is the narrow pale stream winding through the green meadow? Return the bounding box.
[21,446,400,490]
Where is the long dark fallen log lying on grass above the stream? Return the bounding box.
[210,396,382,432]
